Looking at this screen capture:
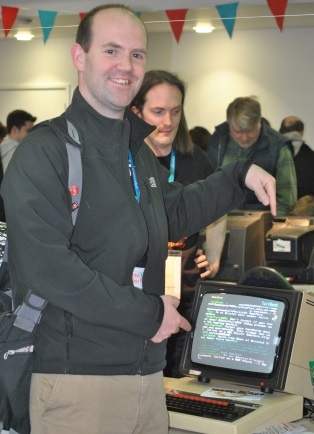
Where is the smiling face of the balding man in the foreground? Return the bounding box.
[71,8,147,118]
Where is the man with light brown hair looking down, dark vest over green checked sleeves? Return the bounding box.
[207,97,297,215]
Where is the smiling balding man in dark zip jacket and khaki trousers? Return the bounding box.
[2,5,276,434]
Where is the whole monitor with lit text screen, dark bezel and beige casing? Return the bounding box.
[180,281,314,399]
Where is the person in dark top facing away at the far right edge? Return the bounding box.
[279,116,314,199]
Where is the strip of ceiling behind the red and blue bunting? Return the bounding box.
[0,0,314,39]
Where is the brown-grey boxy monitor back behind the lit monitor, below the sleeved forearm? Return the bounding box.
[211,210,272,282]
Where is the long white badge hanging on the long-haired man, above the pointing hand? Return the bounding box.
[165,250,182,298]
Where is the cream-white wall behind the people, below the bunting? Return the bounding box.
[0,28,314,147]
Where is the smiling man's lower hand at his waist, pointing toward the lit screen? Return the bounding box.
[151,295,191,344]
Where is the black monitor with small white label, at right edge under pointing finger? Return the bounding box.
[265,216,314,283]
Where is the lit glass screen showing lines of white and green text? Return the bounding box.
[191,291,287,374]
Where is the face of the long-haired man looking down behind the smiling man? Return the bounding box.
[132,83,182,156]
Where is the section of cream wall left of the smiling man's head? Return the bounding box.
[0,39,77,124]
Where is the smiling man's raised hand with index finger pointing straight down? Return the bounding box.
[245,164,276,215]
